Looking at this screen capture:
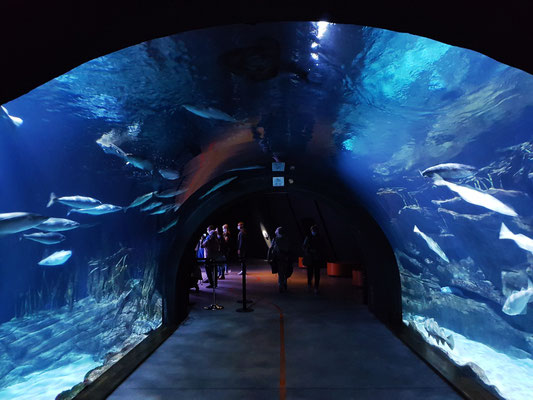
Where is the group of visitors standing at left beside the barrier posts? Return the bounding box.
[192,222,246,292]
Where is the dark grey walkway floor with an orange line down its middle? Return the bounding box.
[109,262,460,400]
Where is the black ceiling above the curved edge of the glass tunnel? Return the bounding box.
[0,0,533,104]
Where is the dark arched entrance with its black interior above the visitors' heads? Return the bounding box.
[164,176,402,327]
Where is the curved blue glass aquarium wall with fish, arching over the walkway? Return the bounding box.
[0,22,533,398]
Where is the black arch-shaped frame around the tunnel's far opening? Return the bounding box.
[165,166,402,327]
